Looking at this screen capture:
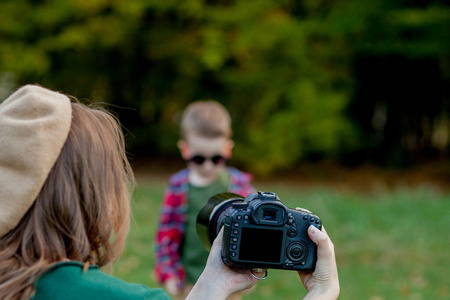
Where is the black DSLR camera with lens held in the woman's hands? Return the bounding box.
[197,192,322,272]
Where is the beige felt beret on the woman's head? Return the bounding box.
[0,85,72,237]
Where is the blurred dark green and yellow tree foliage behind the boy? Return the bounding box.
[0,0,450,173]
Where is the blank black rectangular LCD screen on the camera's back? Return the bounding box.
[239,227,283,263]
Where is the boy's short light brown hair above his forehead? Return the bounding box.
[181,100,232,139]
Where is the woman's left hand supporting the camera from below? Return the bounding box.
[186,229,259,300]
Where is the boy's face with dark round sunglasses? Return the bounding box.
[178,134,234,181]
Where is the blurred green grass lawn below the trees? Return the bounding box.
[114,180,450,300]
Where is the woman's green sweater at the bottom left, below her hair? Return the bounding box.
[32,261,170,300]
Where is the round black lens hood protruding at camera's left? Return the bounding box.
[197,193,244,251]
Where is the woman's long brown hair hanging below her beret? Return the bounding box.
[0,102,134,299]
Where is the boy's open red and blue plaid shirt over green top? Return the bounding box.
[155,167,254,283]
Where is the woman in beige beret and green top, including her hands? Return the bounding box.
[0,86,339,300]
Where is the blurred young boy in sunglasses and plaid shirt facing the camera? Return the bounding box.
[155,101,254,299]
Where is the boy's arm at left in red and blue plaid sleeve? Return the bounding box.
[155,188,186,283]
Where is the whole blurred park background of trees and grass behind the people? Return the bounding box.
[0,0,450,300]
